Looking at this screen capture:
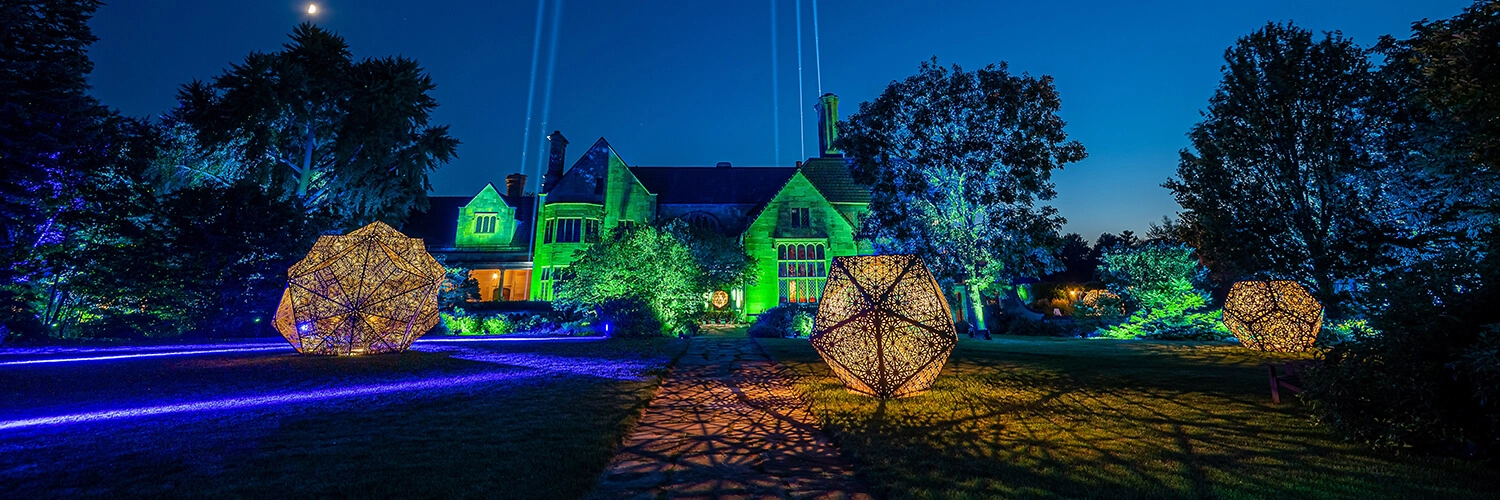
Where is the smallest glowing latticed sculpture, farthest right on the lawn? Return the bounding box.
[1224,281,1323,353]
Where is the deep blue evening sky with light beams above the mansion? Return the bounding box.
[90,0,1469,239]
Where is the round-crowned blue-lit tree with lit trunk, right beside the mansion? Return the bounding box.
[837,59,1086,330]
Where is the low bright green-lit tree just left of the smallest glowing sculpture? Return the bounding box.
[1098,243,1227,339]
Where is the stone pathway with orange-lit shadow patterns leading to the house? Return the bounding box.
[593,330,870,498]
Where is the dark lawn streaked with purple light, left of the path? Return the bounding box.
[0,339,686,498]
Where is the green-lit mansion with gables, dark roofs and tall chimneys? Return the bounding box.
[407,95,870,315]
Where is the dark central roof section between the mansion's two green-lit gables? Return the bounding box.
[630,167,797,204]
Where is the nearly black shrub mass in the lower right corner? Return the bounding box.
[1302,240,1500,455]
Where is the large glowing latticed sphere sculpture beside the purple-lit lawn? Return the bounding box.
[275,221,446,356]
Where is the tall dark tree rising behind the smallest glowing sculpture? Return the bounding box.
[1164,24,1383,314]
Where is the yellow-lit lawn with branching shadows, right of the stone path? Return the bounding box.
[758,336,1500,498]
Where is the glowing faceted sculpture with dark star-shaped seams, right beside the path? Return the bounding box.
[810,255,959,399]
